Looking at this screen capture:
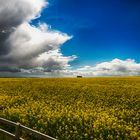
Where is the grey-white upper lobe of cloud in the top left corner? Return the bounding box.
[0,0,48,30]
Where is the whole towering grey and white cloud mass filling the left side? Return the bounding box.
[0,0,76,73]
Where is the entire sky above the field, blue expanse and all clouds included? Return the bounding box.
[0,0,140,77]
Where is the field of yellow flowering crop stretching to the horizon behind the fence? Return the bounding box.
[0,77,140,140]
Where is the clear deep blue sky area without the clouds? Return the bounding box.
[33,0,140,67]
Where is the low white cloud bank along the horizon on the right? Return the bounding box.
[68,58,140,76]
